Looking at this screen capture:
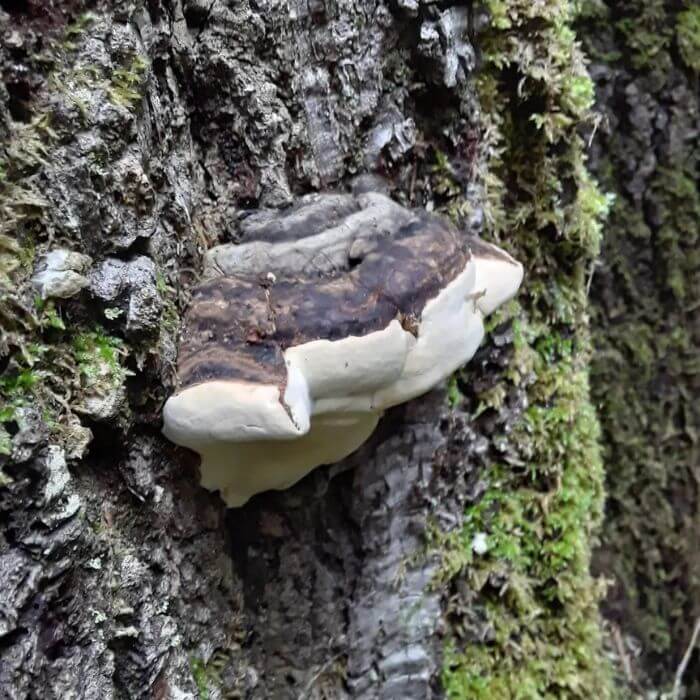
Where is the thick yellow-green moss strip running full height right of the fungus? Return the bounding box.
[436,0,613,699]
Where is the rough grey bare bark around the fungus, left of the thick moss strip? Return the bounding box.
[0,0,492,699]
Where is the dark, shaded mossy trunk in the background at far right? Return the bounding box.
[579,0,700,697]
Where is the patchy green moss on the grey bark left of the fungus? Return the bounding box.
[0,20,139,454]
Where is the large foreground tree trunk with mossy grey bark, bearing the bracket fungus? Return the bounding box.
[0,0,652,700]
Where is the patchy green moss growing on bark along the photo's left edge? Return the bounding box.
[0,13,137,479]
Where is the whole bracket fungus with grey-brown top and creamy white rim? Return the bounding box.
[163,192,523,507]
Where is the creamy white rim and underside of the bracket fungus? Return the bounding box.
[164,249,523,507]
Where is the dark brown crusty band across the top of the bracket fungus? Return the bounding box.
[178,211,470,387]
